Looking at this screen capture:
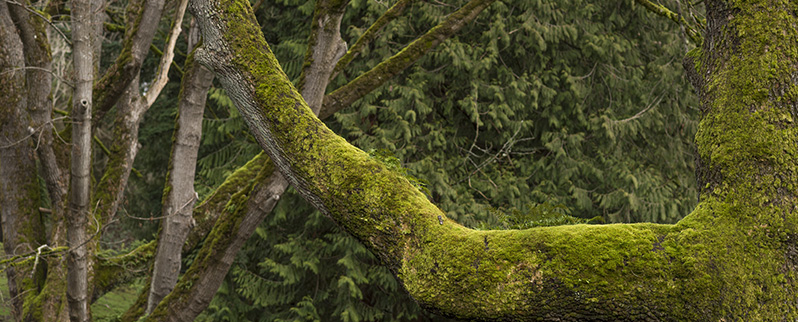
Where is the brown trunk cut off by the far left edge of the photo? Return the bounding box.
[0,3,44,320]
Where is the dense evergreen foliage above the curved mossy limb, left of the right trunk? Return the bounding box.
[330,0,698,226]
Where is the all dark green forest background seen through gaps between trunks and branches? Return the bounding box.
[0,0,700,321]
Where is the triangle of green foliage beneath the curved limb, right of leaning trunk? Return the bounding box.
[198,190,456,321]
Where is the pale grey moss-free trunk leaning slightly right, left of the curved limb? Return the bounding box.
[147,48,213,313]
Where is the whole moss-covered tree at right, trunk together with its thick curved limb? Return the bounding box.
[192,0,798,321]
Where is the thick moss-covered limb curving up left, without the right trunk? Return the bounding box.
[186,1,732,320]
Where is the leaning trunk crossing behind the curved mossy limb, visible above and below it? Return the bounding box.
[148,1,354,314]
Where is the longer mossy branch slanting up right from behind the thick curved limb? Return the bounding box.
[319,0,495,119]
